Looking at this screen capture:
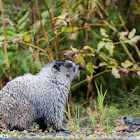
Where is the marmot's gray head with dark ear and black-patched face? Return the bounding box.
[42,60,79,81]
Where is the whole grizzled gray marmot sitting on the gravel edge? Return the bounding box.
[0,60,79,130]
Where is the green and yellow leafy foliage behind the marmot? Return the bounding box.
[0,0,140,117]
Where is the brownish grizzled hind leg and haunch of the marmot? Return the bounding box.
[0,99,36,130]
